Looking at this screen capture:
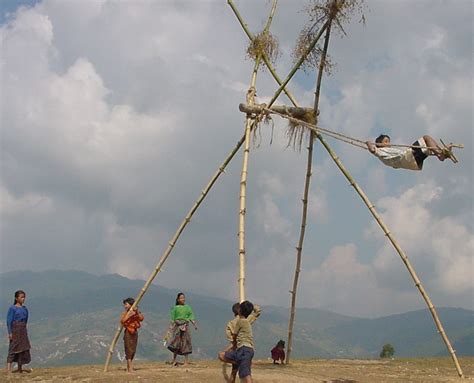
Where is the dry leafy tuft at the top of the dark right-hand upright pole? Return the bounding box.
[293,0,365,71]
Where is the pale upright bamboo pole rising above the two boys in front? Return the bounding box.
[238,0,278,302]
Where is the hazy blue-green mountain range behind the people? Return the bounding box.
[0,271,474,366]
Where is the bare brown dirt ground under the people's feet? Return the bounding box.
[0,357,474,383]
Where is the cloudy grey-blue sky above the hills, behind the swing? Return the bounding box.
[0,0,474,317]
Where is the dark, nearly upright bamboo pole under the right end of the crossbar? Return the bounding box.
[286,23,331,364]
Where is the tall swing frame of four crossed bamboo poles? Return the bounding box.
[104,0,463,378]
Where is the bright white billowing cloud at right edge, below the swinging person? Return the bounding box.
[371,183,474,294]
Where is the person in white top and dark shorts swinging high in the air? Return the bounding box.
[366,134,450,170]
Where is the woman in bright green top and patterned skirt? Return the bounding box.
[168,293,197,366]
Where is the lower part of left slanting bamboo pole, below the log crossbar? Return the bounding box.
[104,135,245,372]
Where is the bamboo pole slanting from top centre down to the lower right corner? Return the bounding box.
[228,6,464,378]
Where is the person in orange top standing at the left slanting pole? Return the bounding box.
[120,298,145,372]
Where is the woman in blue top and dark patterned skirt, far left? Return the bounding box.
[7,290,31,373]
